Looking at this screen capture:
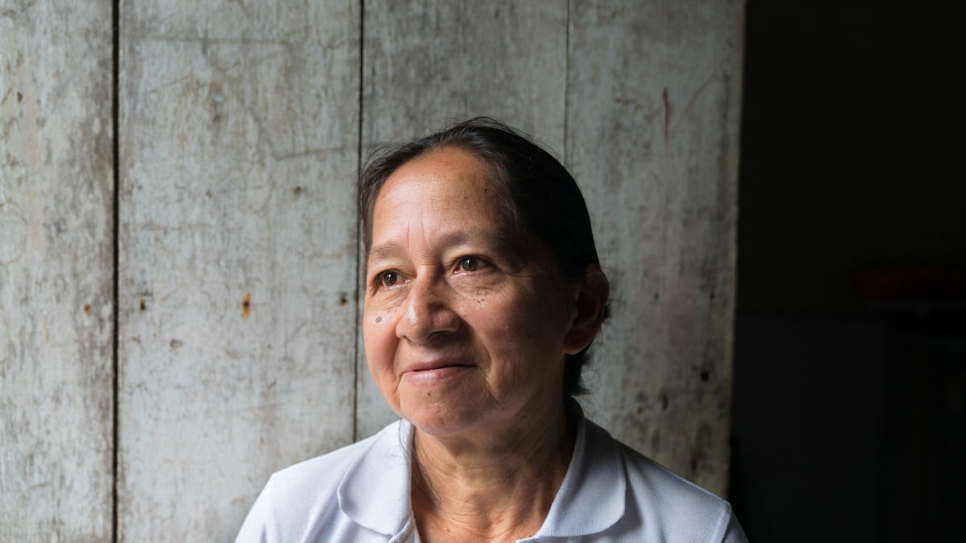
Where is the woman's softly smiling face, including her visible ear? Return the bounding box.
[363,148,583,436]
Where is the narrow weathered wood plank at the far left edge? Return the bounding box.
[0,0,114,541]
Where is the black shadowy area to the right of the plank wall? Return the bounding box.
[731,0,966,542]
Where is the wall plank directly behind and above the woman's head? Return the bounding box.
[357,0,567,438]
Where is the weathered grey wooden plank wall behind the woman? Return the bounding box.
[0,0,744,541]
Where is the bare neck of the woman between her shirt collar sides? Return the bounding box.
[412,402,576,543]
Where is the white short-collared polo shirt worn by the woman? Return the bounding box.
[236,407,747,543]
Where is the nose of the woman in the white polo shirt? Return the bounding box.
[396,278,460,343]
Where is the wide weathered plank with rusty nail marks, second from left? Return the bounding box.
[118,0,360,541]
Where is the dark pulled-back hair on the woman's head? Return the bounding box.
[359,117,606,396]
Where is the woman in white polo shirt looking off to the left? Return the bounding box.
[238,119,745,543]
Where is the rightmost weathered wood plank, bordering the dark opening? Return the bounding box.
[567,0,744,494]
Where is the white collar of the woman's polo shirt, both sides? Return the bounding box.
[338,401,627,538]
